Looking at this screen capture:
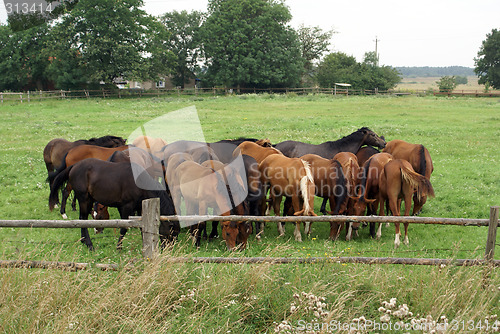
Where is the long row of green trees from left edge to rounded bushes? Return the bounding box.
[0,0,496,91]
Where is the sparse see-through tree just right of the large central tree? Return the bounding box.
[297,24,335,82]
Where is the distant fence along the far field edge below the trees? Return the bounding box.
[0,87,500,104]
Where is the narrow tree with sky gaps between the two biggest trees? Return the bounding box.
[160,10,203,88]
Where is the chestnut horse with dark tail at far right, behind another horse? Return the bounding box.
[383,140,434,215]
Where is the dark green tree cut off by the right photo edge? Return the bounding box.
[474,29,500,89]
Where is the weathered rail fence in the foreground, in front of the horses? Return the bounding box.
[0,198,500,270]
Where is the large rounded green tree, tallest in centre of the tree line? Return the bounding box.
[202,0,303,87]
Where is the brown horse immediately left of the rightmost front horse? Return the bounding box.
[352,153,393,239]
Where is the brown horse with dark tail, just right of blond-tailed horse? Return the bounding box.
[301,154,348,240]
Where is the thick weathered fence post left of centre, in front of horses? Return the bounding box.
[142,198,160,259]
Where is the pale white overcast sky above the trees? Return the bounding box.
[0,0,500,67]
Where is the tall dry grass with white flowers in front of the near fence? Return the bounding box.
[0,246,500,333]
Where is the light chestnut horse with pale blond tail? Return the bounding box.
[259,154,316,241]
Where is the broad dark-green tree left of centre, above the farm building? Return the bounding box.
[52,0,169,84]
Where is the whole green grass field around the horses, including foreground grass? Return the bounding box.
[0,95,500,333]
